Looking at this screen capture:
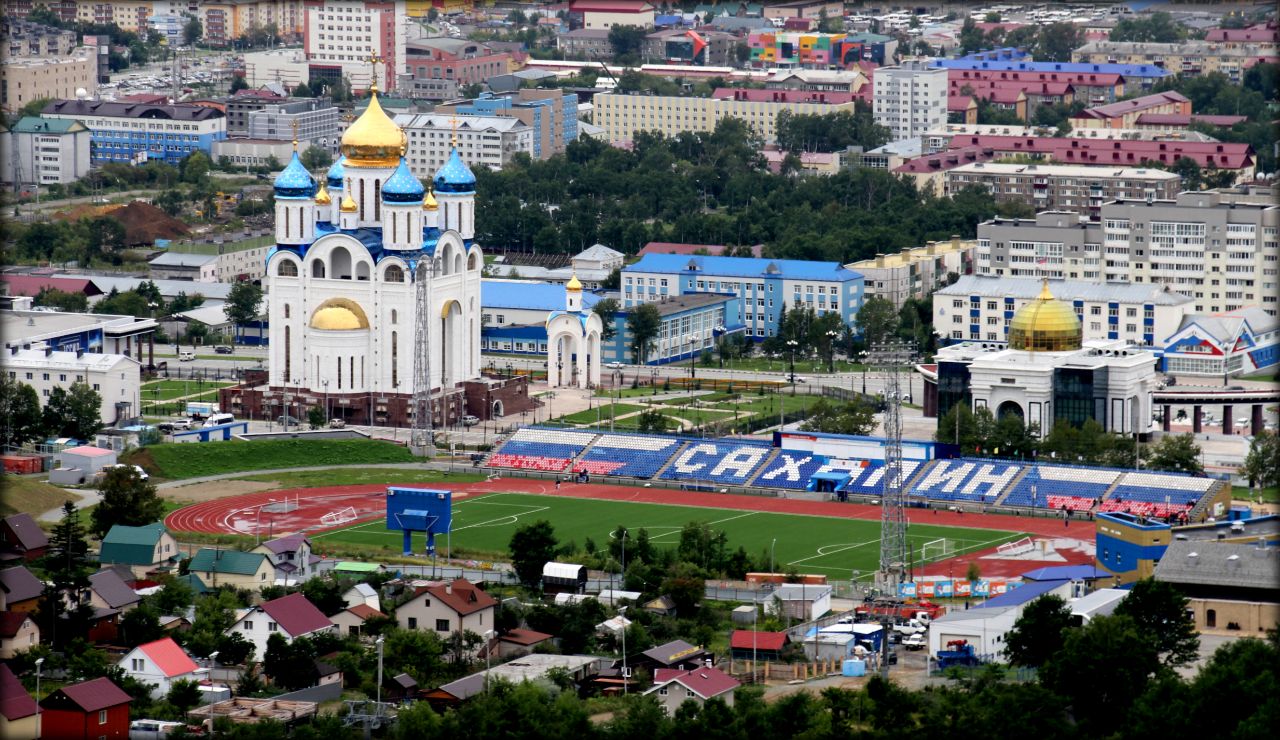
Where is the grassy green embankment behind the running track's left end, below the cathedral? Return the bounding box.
[122,439,416,480]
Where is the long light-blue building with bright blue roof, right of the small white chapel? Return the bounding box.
[621,255,864,341]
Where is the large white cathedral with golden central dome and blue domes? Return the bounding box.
[253,83,484,425]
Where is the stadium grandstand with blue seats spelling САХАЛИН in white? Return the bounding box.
[483,426,1230,519]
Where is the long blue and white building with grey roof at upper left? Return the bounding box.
[41,100,227,166]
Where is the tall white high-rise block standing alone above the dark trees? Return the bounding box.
[872,61,947,140]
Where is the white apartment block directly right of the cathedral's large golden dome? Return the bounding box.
[396,114,534,179]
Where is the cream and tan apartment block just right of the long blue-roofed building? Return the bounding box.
[845,237,978,307]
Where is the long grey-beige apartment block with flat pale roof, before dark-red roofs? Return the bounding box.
[943,161,1183,220]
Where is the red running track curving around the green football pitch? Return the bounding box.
[165,478,1094,540]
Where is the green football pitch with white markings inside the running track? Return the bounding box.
[311,493,1025,577]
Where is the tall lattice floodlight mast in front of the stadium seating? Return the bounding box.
[868,341,915,598]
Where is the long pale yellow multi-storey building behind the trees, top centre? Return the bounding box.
[593,90,854,143]
